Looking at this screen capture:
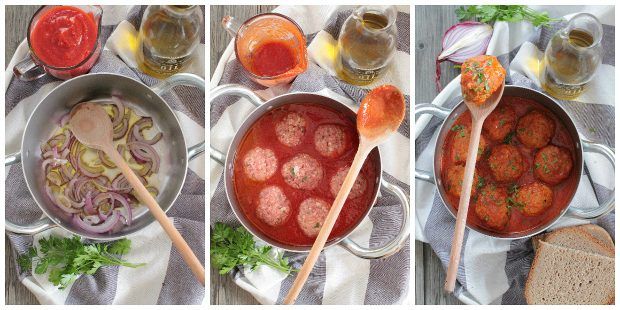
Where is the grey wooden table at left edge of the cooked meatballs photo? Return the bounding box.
[414,5,462,305]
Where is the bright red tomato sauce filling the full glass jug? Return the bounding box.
[29,6,98,68]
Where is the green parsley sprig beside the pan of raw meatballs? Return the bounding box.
[211,222,298,274]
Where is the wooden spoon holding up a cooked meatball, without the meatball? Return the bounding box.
[444,77,504,293]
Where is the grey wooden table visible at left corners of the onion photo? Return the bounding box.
[4,5,39,305]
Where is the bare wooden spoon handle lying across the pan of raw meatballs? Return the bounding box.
[284,139,374,305]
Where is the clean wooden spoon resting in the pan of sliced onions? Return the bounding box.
[69,102,205,286]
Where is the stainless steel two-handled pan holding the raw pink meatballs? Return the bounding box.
[210,85,409,258]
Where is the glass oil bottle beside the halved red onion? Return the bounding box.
[540,13,603,100]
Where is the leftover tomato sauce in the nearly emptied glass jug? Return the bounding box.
[251,41,296,76]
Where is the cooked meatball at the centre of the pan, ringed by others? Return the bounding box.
[489,144,525,182]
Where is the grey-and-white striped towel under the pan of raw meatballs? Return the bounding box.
[210,6,410,304]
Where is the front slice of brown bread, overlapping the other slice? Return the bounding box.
[525,241,615,305]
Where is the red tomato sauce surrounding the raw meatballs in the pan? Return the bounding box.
[233,103,379,246]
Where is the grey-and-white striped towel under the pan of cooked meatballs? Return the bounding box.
[415,6,615,304]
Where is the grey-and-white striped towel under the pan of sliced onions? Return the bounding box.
[5,6,205,304]
